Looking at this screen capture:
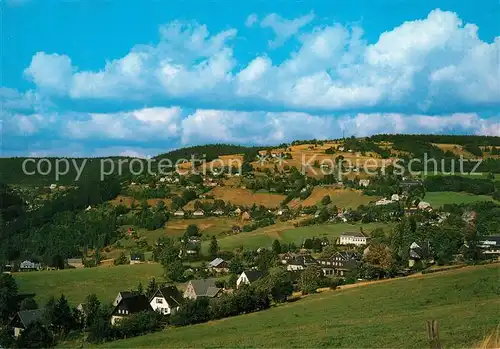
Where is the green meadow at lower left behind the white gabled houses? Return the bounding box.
[13,263,163,305]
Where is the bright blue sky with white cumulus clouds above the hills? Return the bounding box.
[0,0,500,156]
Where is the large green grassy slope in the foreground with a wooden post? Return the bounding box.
[93,265,500,348]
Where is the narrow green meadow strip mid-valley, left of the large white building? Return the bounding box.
[202,222,391,251]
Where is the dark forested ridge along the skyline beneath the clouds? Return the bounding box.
[0,134,500,185]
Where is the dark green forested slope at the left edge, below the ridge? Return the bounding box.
[0,179,120,264]
